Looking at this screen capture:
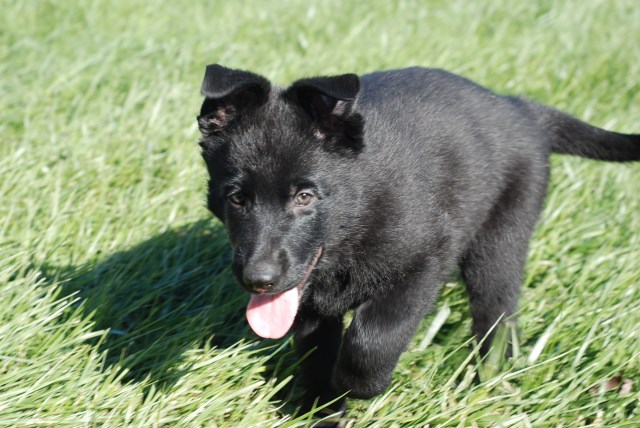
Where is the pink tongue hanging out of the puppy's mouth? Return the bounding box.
[247,287,299,339]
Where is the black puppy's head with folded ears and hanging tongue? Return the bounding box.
[198,65,363,337]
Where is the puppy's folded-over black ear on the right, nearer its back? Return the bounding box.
[285,74,364,152]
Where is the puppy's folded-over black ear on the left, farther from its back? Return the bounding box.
[198,64,271,135]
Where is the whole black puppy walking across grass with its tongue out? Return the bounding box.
[198,65,640,408]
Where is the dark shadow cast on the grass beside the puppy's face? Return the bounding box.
[41,220,302,402]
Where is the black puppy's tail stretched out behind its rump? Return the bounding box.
[532,103,640,162]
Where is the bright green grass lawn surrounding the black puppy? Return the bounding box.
[0,0,640,427]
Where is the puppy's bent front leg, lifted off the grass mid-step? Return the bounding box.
[332,283,438,398]
